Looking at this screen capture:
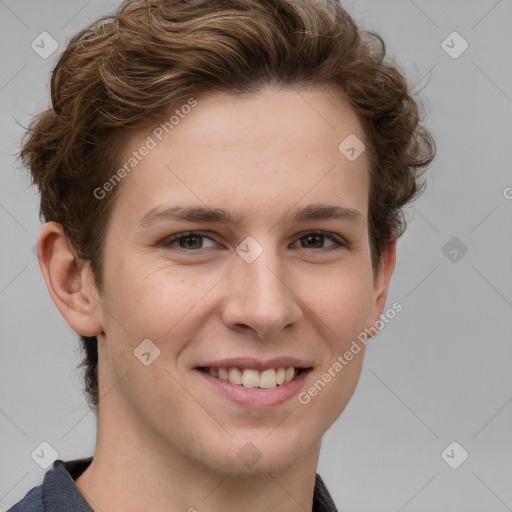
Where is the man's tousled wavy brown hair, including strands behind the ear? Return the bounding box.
[20,0,435,414]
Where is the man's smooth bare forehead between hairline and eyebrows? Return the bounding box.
[111,88,369,228]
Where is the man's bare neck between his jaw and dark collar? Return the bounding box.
[75,394,321,512]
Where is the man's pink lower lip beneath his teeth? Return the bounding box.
[196,368,311,406]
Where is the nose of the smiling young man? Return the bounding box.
[222,241,302,339]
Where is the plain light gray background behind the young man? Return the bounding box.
[0,0,512,512]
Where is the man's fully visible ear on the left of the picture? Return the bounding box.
[37,222,103,336]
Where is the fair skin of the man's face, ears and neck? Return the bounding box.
[39,88,395,512]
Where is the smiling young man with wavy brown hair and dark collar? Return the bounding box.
[11,0,434,512]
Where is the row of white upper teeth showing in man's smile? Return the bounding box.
[208,366,296,388]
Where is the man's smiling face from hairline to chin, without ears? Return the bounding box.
[92,85,394,474]
